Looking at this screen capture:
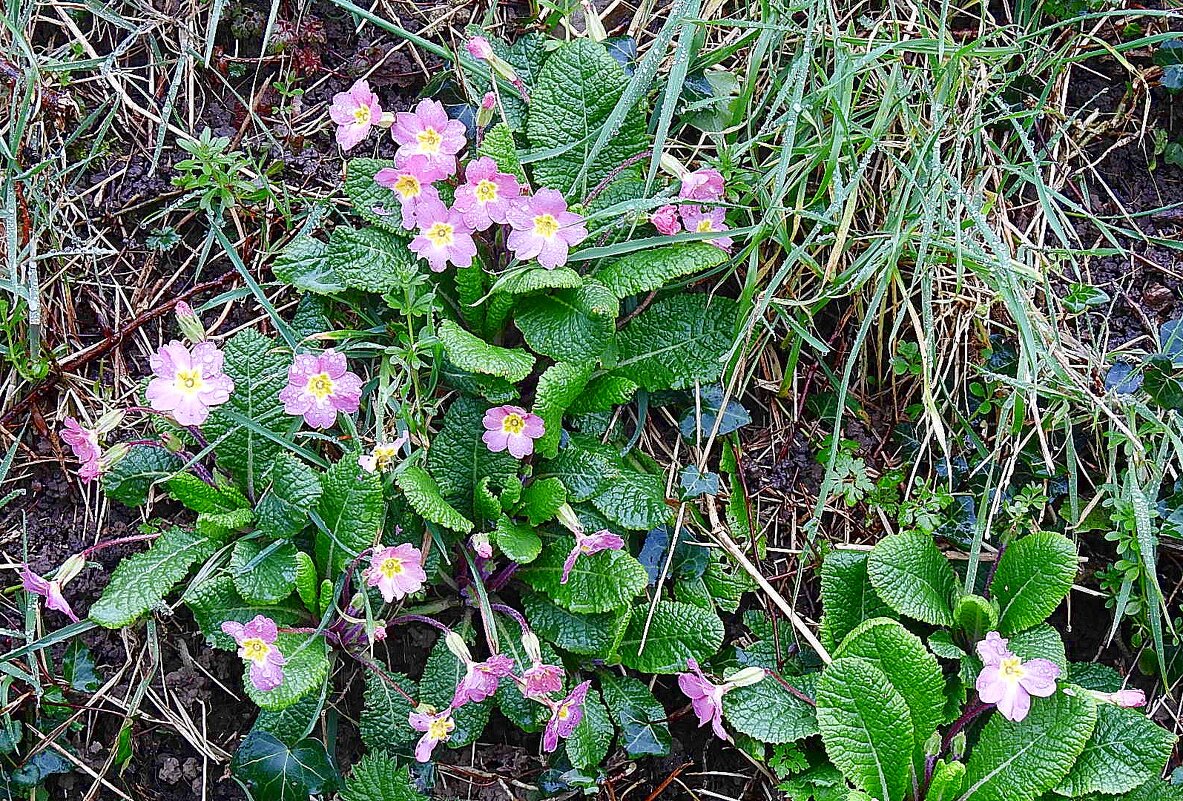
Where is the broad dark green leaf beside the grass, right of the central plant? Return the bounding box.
[615,295,738,392]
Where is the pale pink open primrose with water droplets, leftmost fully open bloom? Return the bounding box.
[144,340,234,426]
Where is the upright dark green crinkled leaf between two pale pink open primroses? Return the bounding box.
[202,329,291,489]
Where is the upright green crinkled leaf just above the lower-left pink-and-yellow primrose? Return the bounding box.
[316,454,384,577]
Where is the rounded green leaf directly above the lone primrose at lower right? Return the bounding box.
[990,531,1077,637]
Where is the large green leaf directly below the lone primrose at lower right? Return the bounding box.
[962,692,1097,801]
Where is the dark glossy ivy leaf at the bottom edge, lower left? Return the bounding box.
[230,731,337,801]
